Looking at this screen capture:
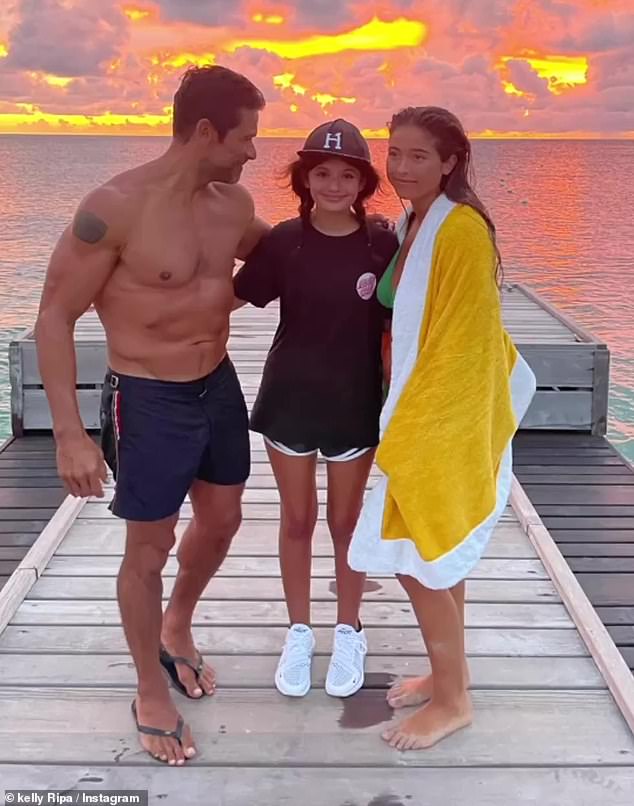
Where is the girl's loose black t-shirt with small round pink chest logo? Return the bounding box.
[234,219,398,450]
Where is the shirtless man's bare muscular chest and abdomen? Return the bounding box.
[95,166,248,381]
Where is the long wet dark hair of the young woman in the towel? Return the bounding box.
[389,106,503,286]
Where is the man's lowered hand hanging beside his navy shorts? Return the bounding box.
[57,431,108,498]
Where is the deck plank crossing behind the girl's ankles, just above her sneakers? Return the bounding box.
[11,599,574,630]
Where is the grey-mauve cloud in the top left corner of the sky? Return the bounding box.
[7,0,127,76]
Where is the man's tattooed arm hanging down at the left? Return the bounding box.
[35,189,121,496]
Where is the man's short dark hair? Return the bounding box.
[172,65,265,143]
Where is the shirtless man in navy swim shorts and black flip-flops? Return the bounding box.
[35,66,267,765]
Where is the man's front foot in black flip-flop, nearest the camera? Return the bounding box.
[132,695,196,766]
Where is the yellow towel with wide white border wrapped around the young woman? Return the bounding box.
[349,196,535,587]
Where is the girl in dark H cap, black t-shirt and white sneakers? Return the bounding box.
[234,119,398,697]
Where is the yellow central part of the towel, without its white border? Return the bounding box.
[376,207,517,560]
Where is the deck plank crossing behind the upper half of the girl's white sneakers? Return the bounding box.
[0,624,588,657]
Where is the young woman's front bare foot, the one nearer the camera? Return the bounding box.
[382,692,473,750]
